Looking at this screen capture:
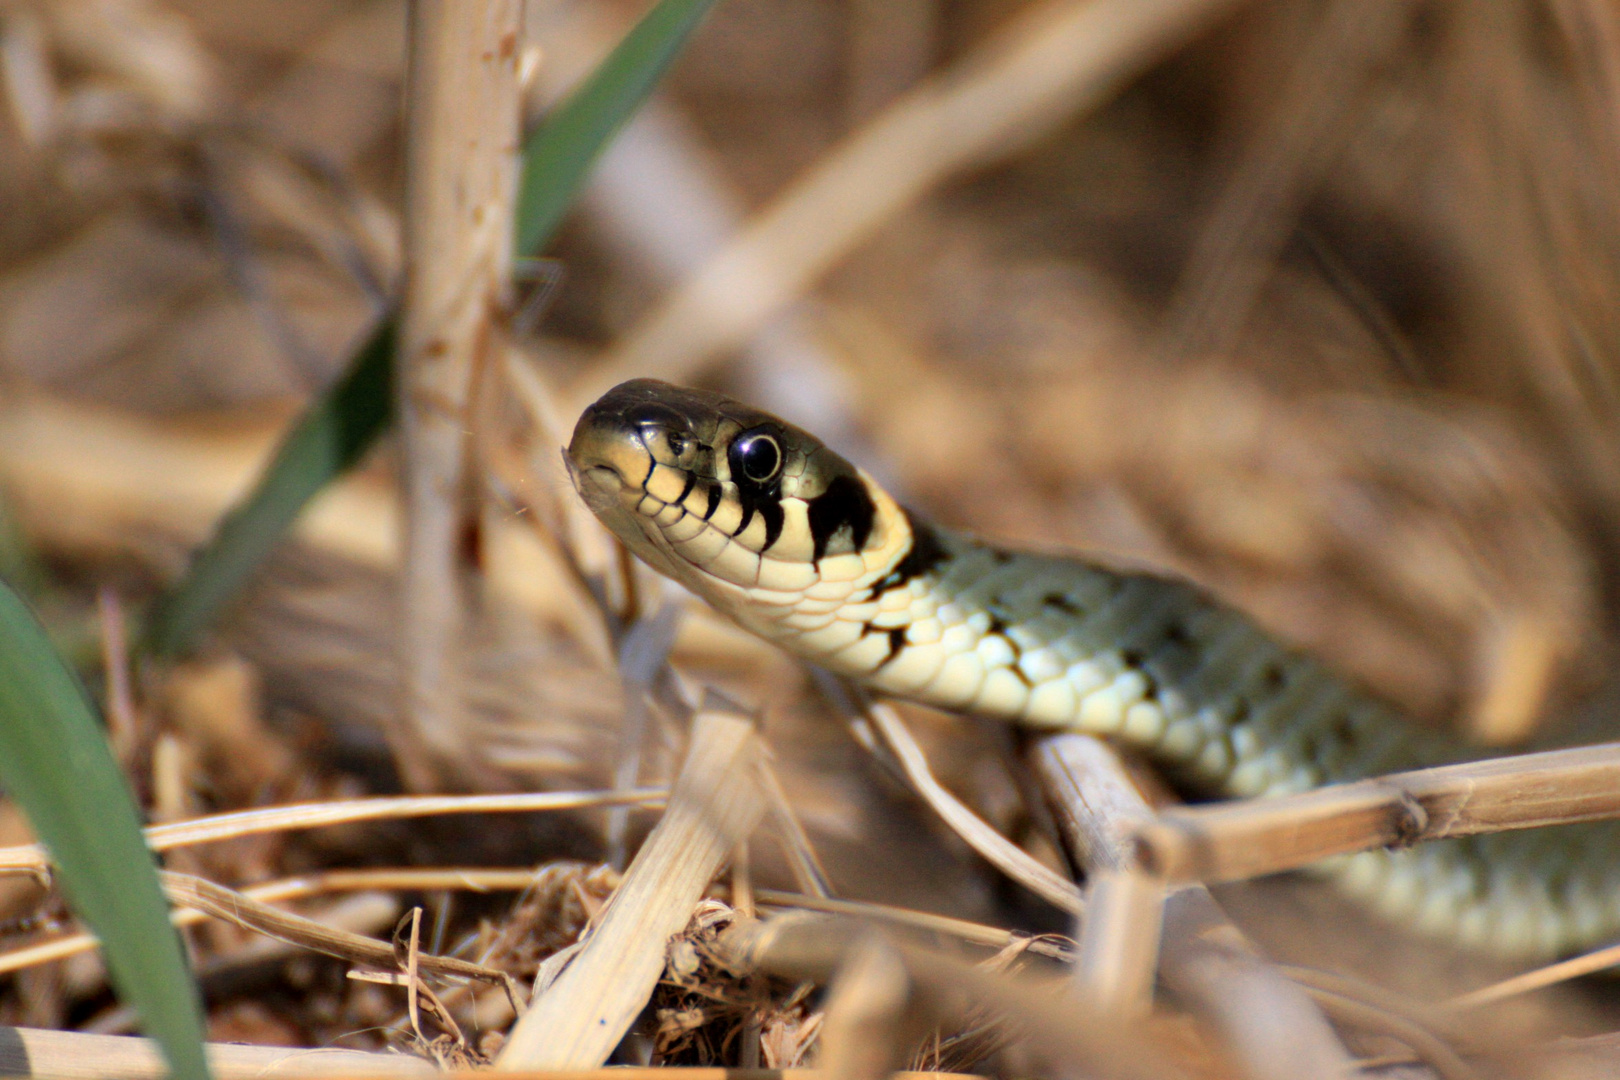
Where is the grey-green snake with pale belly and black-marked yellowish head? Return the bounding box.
[565,379,1620,960]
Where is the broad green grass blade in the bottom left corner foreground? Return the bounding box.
[0,585,209,1080]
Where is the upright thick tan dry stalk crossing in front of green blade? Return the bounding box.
[392,0,522,790]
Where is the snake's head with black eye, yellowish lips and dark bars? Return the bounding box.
[567,379,909,622]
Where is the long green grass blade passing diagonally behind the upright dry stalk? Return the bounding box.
[146,0,714,656]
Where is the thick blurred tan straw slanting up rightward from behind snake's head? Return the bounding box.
[573,0,1236,403]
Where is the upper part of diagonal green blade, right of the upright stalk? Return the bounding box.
[517,0,714,254]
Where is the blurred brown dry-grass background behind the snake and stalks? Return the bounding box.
[0,0,1620,1075]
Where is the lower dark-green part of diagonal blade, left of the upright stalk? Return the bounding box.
[146,322,394,656]
